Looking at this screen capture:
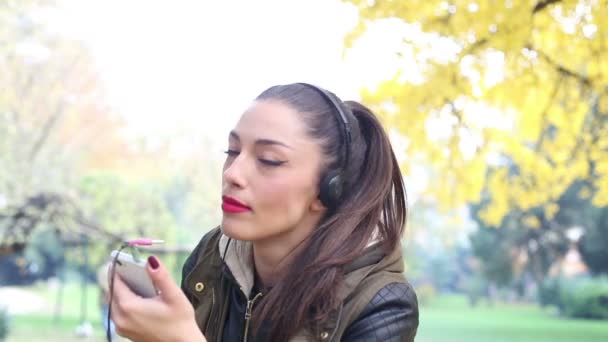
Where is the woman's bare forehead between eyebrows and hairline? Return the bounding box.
[235,100,309,142]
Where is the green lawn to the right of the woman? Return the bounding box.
[416,296,608,342]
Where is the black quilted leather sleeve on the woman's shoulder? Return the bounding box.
[344,282,419,341]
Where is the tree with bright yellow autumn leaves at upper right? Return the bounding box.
[346,0,608,226]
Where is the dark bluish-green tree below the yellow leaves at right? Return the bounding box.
[471,181,608,292]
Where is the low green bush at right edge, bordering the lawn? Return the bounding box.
[538,277,608,320]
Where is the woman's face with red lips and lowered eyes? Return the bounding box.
[222,100,324,241]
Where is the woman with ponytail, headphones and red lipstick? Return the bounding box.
[112,83,418,341]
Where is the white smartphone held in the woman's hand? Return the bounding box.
[110,250,158,298]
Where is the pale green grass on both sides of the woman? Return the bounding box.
[6,284,608,342]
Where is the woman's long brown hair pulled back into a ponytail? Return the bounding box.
[253,84,407,342]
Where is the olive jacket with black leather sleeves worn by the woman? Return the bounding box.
[182,227,419,342]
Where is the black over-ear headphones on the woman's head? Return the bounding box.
[298,83,353,209]
